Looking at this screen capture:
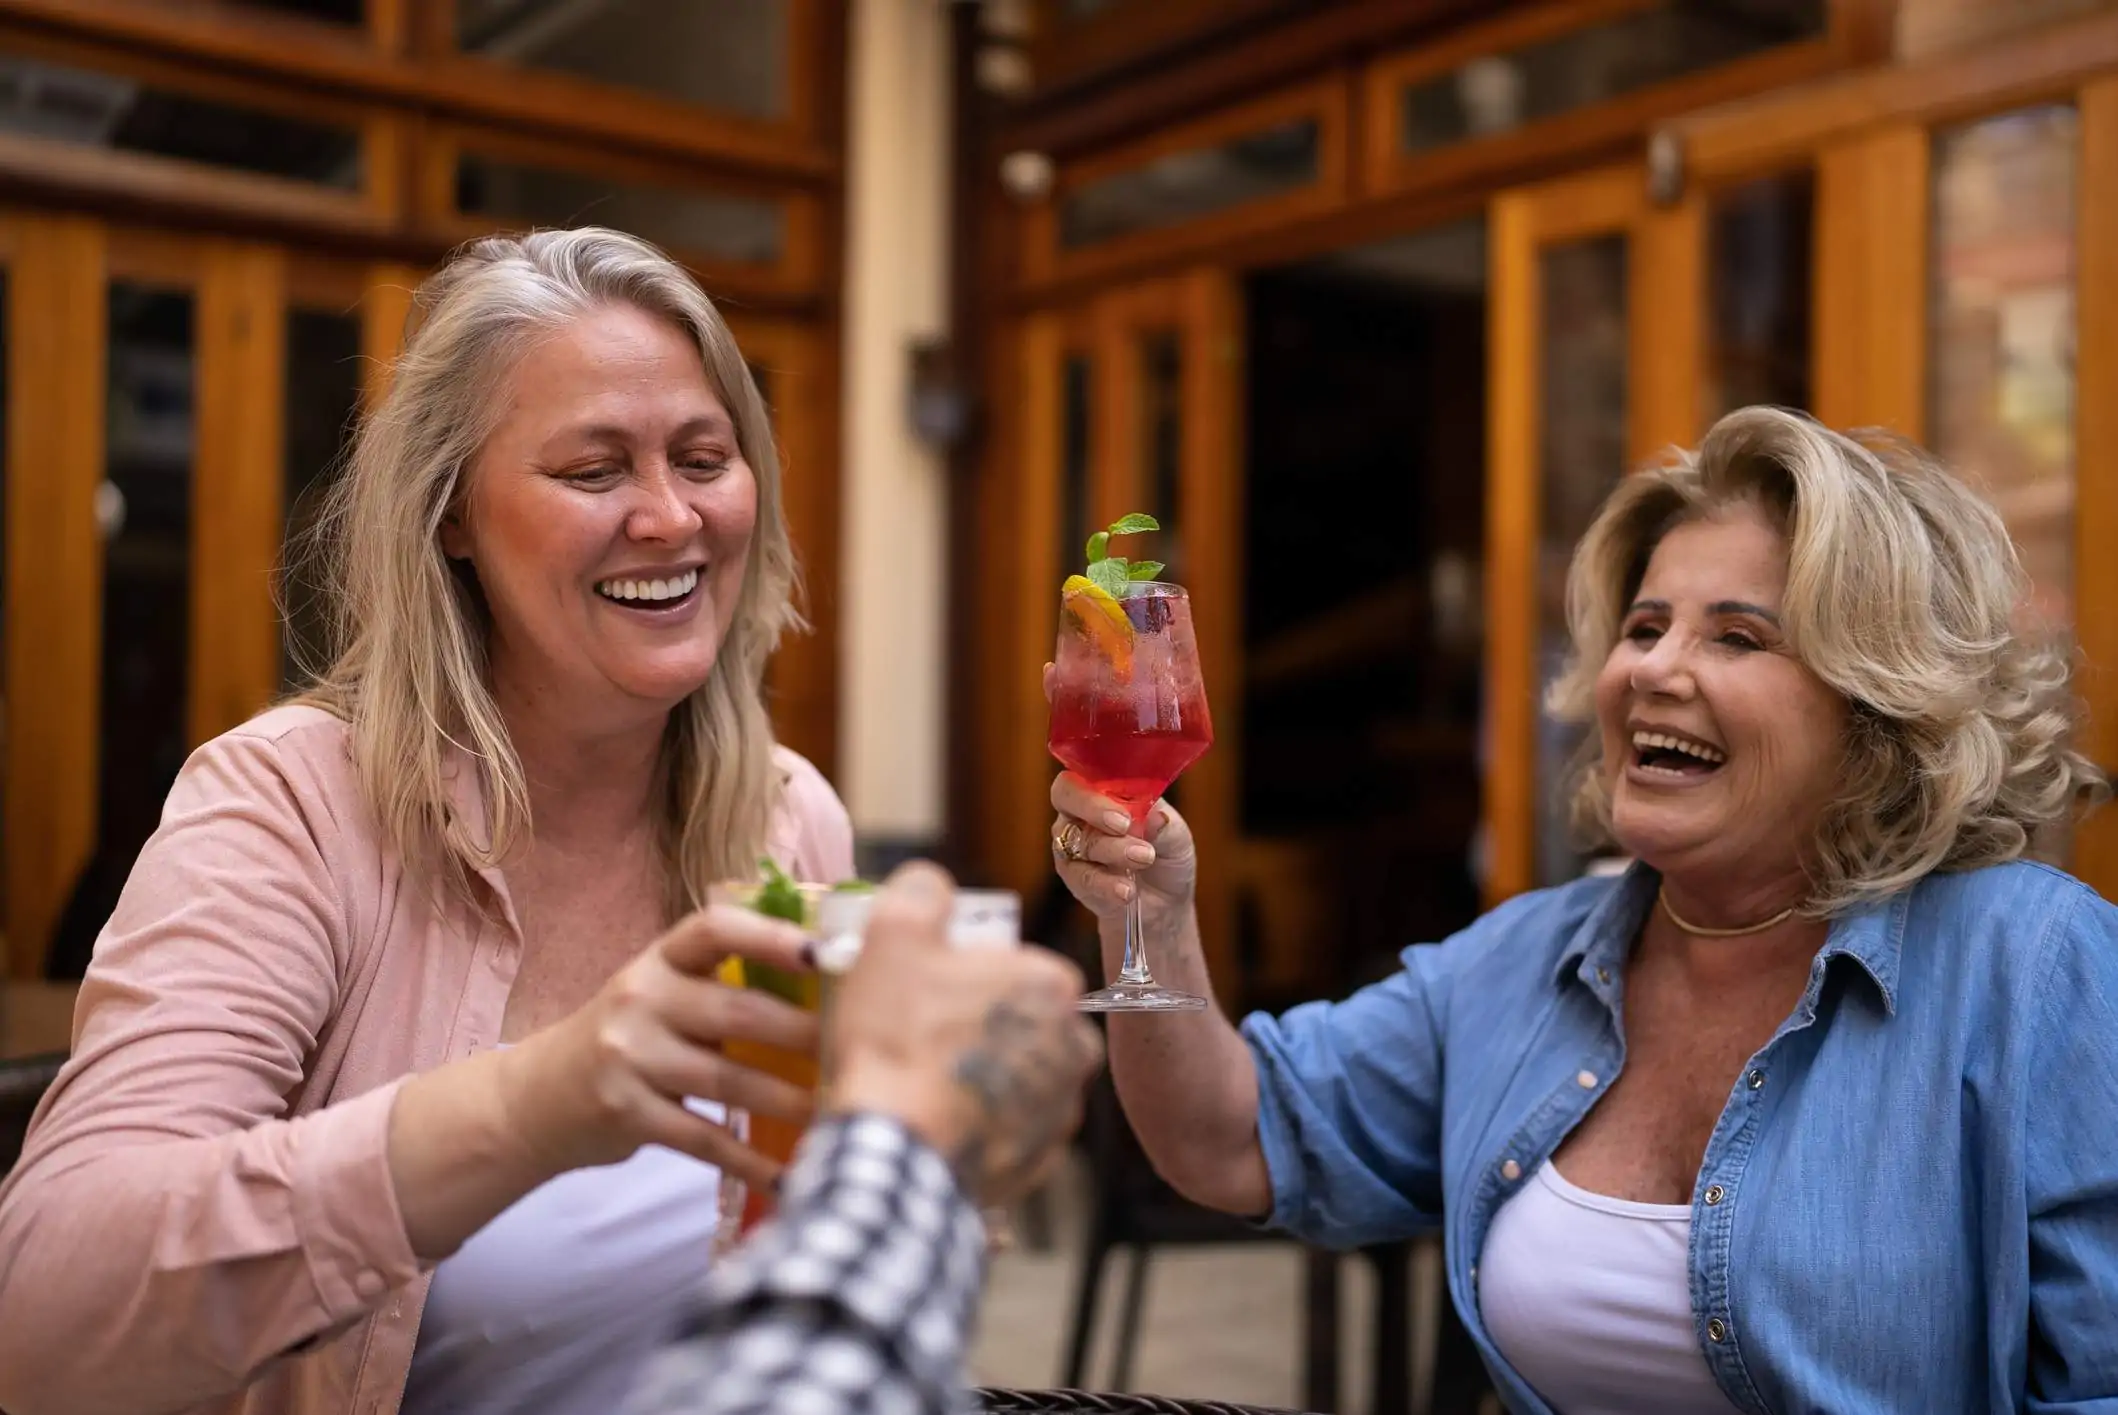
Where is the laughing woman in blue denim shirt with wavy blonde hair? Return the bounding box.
[1053,409,2118,1415]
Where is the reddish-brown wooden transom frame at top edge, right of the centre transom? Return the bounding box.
[1360,0,1862,195]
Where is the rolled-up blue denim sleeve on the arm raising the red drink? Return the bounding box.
[1243,907,1508,1248]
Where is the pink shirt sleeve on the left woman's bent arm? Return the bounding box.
[0,733,419,1415]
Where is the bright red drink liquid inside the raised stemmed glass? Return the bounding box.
[1051,682,1214,832]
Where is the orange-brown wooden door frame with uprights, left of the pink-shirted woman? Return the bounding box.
[0,210,417,979]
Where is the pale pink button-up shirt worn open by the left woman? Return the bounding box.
[0,708,854,1415]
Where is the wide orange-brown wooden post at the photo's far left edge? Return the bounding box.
[6,216,108,979]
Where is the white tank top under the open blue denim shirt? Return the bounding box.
[1478,1163,1735,1415]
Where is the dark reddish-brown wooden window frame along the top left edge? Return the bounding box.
[0,0,845,182]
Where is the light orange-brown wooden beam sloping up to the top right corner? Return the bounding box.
[1669,13,2118,182]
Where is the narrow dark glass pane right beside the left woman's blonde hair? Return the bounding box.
[280,309,360,688]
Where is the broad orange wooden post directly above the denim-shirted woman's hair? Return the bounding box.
[1815,123,1929,438]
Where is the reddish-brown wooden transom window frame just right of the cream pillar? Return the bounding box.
[1021,76,1351,288]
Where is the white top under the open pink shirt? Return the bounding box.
[400,1099,722,1415]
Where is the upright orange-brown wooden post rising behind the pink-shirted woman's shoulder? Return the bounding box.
[189,241,286,746]
